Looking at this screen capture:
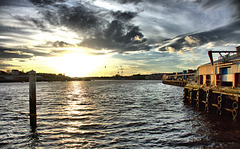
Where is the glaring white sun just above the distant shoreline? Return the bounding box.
[49,53,104,77]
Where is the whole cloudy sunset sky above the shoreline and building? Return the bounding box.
[0,0,240,77]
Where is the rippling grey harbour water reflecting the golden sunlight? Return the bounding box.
[0,81,240,148]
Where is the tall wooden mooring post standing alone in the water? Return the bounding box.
[29,70,37,130]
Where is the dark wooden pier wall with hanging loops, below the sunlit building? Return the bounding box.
[183,84,240,121]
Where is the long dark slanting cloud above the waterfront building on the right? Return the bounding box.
[159,21,240,51]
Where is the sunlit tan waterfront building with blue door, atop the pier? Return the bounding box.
[195,47,240,88]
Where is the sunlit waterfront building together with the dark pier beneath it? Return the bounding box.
[183,46,240,121]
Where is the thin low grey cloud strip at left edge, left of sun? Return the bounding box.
[0,47,50,59]
